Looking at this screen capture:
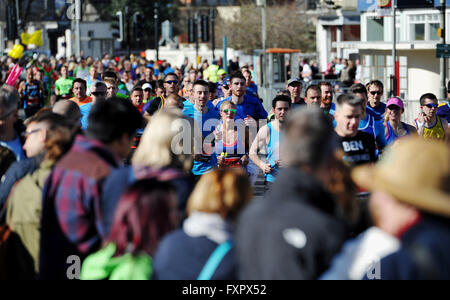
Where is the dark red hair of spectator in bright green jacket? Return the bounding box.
[107,179,175,256]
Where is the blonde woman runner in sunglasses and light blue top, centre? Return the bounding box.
[214,101,249,169]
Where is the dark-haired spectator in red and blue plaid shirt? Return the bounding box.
[39,98,142,279]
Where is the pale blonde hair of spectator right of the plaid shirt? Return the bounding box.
[132,110,194,172]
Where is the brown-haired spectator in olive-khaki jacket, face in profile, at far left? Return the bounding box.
[6,111,72,279]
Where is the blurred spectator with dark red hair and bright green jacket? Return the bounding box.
[81,179,178,280]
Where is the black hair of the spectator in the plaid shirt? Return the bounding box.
[86,97,142,144]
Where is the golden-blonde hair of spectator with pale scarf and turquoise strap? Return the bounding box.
[187,169,252,219]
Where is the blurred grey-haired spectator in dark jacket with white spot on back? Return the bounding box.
[236,106,347,280]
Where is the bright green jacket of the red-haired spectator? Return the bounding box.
[80,243,152,280]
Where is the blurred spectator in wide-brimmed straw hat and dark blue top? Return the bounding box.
[353,137,450,280]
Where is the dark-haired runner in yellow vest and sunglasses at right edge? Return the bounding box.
[416,93,448,140]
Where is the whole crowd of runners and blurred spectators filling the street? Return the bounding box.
[0,55,450,280]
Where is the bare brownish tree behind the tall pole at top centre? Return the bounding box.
[216,3,316,54]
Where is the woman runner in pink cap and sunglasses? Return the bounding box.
[384,97,416,145]
